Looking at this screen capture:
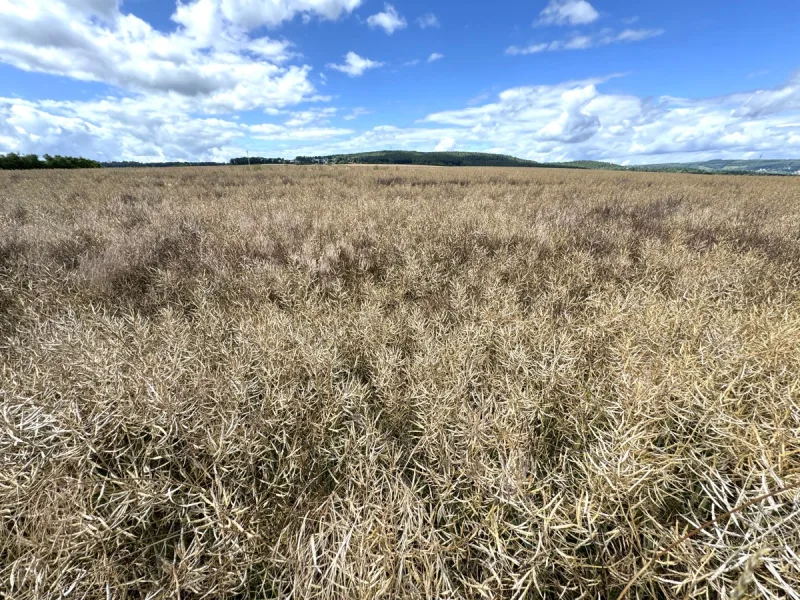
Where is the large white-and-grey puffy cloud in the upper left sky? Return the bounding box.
[0,0,340,112]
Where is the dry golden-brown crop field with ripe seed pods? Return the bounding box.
[0,167,800,599]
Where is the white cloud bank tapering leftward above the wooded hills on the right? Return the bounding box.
[276,73,800,164]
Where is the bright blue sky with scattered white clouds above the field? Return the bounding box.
[0,0,800,164]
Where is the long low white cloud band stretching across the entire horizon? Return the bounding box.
[6,78,800,163]
